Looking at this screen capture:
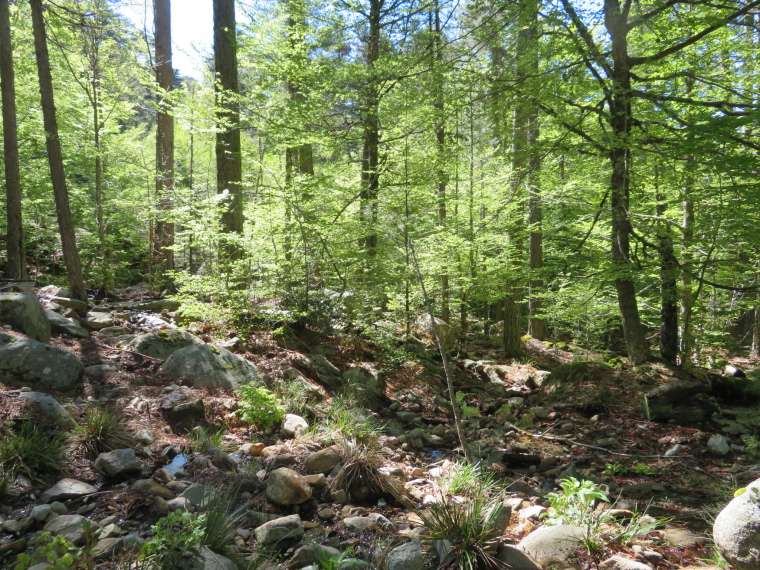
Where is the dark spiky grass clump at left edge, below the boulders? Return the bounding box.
[0,420,67,482]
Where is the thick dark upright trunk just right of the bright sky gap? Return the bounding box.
[214,0,243,261]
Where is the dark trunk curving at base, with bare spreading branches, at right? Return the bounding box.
[604,0,651,364]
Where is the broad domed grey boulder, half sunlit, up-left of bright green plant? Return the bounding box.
[159,344,261,389]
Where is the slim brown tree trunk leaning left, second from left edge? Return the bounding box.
[29,0,87,301]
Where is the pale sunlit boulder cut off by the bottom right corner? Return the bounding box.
[713,472,760,570]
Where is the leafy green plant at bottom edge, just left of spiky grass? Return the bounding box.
[139,511,206,570]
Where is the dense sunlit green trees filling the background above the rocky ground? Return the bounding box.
[0,0,760,363]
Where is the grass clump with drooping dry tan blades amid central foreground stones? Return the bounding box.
[333,439,413,507]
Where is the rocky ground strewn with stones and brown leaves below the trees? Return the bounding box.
[0,282,760,570]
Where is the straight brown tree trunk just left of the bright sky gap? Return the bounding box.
[152,0,174,273]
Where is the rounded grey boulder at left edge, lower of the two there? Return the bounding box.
[0,333,84,391]
